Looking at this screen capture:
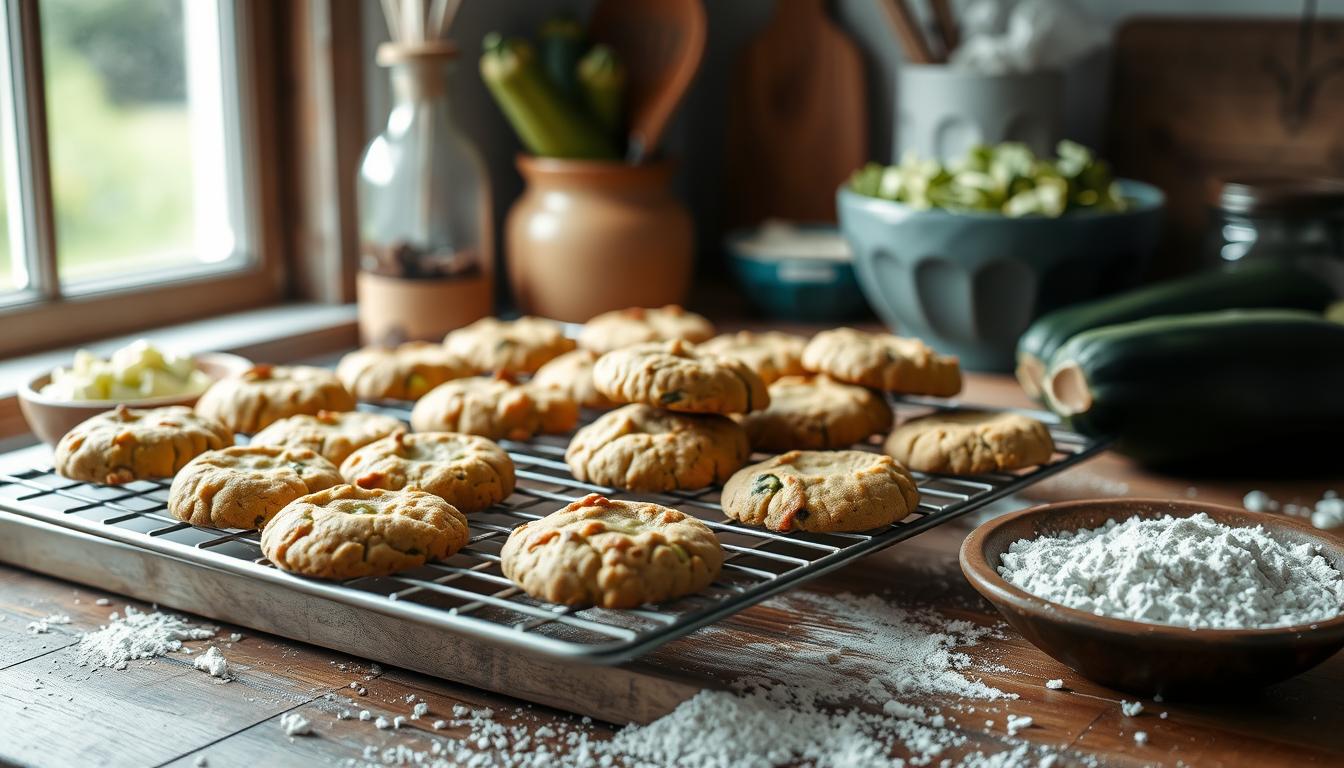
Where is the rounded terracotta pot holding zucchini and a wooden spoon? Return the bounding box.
[504,155,695,323]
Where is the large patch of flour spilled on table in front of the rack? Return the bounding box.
[333,593,1095,768]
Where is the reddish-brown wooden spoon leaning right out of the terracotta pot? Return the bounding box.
[589,0,706,163]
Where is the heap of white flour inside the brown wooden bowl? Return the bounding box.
[999,512,1344,628]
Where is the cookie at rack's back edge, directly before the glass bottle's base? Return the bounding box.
[336,342,476,399]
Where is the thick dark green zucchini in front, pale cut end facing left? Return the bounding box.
[1043,309,1344,471]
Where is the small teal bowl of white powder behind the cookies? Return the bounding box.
[724,225,868,323]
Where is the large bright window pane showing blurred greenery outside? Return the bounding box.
[40,0,237,284]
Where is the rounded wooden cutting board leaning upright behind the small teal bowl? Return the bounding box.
[724,0,868,226]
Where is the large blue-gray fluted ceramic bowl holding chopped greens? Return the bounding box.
[836,180,1165,371]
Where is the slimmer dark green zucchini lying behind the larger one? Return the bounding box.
[1017,261,1335,401]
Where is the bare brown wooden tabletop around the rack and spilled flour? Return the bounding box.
[0,377,1344,767]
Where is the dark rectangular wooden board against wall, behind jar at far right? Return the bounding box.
[1107,16,1344,276]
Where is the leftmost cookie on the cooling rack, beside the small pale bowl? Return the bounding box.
[55,405,234,483]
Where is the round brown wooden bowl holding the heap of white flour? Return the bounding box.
[961,499,1344,697]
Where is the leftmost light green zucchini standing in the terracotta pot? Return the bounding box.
[481,32,617,160]
